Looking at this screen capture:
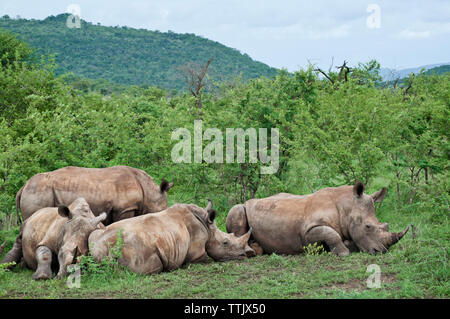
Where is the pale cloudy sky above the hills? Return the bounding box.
[0,0,450,71]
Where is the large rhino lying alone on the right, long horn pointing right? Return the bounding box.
[226,182,409,256]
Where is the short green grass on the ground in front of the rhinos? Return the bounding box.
[0,200,450,299]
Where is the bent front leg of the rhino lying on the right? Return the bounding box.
[305,226,350,256]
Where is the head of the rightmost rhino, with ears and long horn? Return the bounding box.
[348,181,409,254]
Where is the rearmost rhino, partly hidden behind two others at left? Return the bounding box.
[16,166,173,224]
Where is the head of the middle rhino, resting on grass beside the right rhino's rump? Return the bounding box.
[206,201,256,261]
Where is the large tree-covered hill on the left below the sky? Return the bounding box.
[0,14,277,89]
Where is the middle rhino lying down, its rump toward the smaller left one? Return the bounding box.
[89,204,254,274]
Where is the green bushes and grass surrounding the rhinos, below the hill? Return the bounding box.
[0,28,450,298]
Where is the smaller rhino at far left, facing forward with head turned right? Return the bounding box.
[1,198,106,280]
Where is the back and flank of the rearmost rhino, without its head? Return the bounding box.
[19,166,143,224]
